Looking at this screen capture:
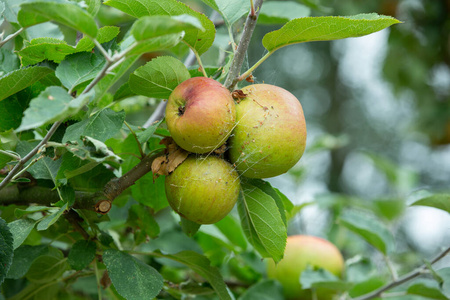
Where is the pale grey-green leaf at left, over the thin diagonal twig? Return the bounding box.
[16,86,93,132]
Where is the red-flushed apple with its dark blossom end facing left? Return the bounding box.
[166,77,236,154]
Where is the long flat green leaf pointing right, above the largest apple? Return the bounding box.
[262,13,400,52]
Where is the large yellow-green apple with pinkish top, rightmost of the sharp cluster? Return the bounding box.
[229,84,306,178]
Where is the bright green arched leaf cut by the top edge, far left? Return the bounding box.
[17,1,97,38]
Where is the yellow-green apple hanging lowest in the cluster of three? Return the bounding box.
[165,154,240,224]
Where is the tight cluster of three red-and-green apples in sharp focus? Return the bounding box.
[165,77,306,224]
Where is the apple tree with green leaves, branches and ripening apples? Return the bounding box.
[0,0,450,300]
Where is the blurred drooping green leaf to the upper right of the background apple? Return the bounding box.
[338,211,395,255]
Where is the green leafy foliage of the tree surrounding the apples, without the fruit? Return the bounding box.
[0,0,450,299]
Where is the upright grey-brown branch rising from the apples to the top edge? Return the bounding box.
[224,0,263,91]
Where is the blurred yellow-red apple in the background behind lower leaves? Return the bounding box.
[267,235,344,299]
